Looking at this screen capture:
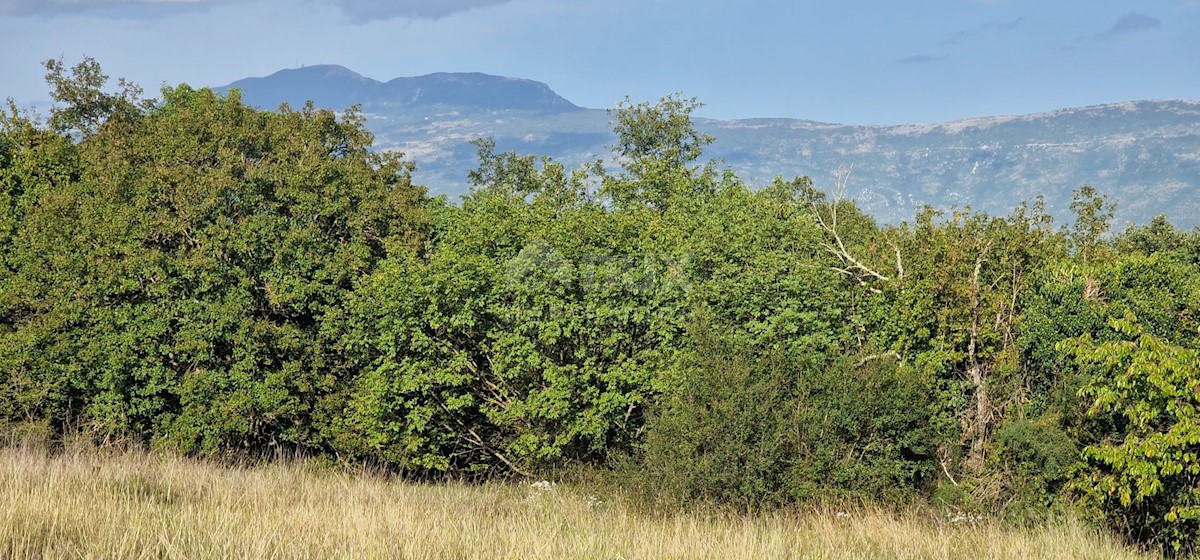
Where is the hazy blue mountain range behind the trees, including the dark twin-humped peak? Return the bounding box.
[217,65,1200,228]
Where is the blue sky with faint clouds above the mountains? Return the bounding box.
[0,0,1200,125]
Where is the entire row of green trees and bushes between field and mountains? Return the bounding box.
[7,60,1200,553]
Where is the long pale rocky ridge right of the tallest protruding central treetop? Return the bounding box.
[706,101,1200,227]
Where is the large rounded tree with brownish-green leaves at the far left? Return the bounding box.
[2,65,424,452]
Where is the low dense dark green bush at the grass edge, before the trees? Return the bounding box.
[642,332,934,510]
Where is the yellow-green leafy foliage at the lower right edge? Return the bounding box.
[1062,314,1200,554]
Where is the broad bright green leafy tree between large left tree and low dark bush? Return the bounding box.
[333,137,683,472]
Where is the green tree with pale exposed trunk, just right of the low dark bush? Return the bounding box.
[844,204,1060,484]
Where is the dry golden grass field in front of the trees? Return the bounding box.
[0,448,1147,559]
